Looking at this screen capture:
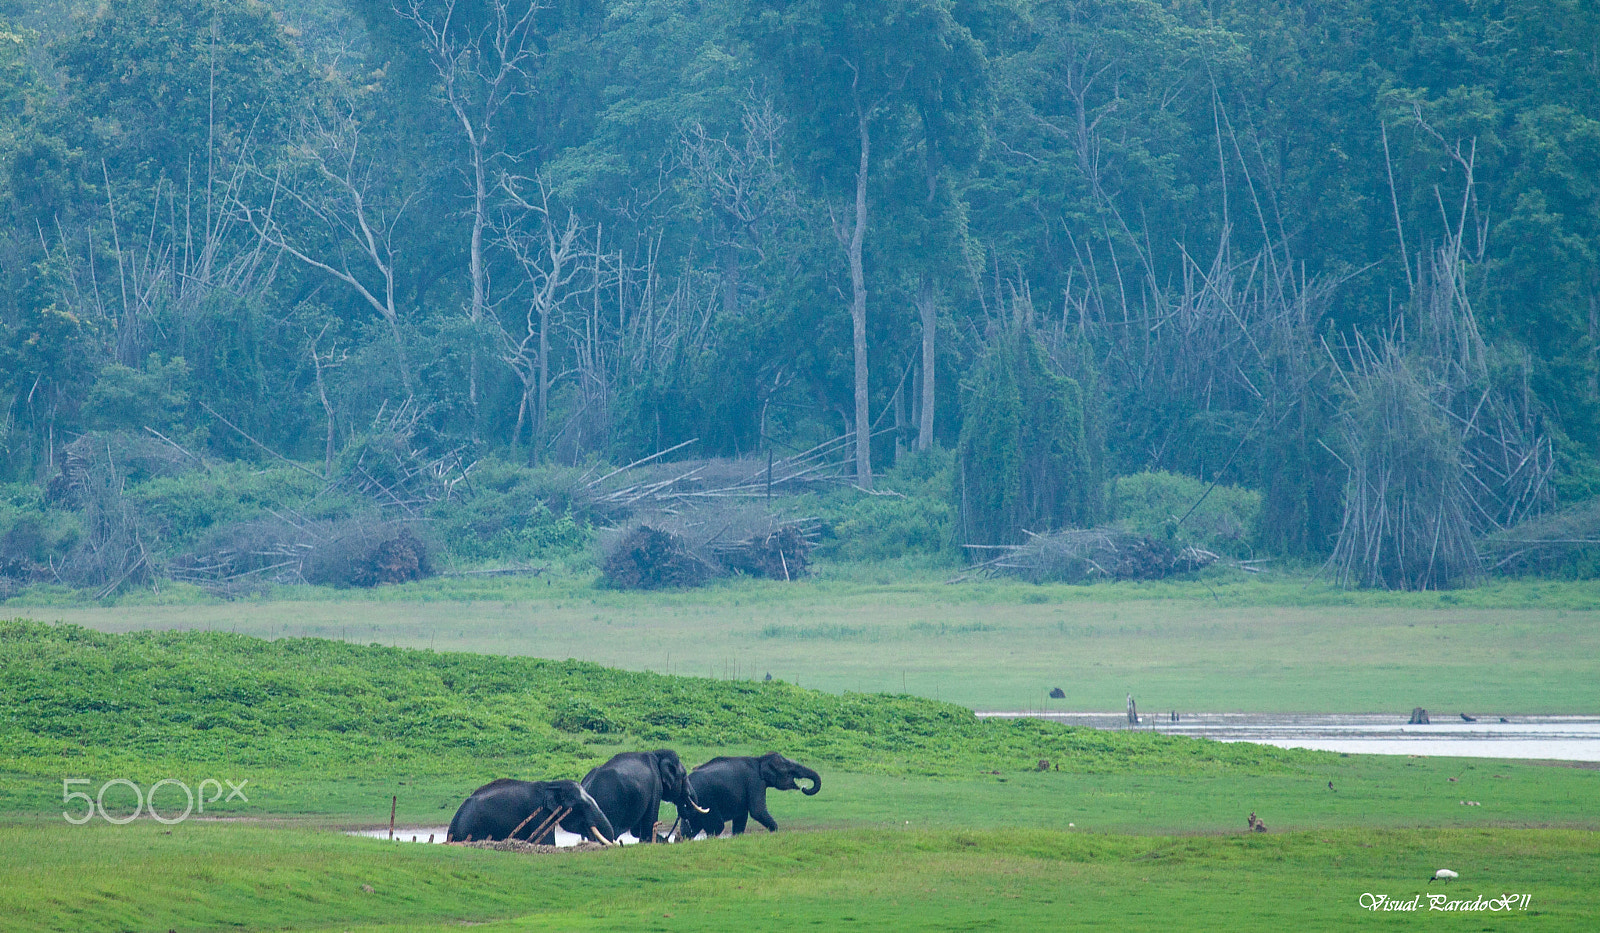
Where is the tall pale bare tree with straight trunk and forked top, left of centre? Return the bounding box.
[394,0,547,411]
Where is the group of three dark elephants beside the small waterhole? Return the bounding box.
[445,749,822,845]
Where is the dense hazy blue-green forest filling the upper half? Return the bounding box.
[0,0,1600,592]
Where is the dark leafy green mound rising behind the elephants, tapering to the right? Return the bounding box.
[0,619,1318,776]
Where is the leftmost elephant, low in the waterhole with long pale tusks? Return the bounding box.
[445,778,616,845]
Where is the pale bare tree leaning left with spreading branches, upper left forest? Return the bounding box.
[234,102,413,394]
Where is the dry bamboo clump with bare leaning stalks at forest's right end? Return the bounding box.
[1328,128,1555,589]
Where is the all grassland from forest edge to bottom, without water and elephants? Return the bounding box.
[0,579,1600,933]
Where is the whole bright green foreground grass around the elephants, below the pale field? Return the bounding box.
[0,621,1600,933]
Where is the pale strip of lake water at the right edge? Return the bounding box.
[978,711,1600,762]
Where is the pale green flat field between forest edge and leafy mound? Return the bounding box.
[21,568,1600,714]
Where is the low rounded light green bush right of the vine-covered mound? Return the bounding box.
[1110,471,1261,557]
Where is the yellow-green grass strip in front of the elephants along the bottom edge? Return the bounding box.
[0,824,1600,933]
